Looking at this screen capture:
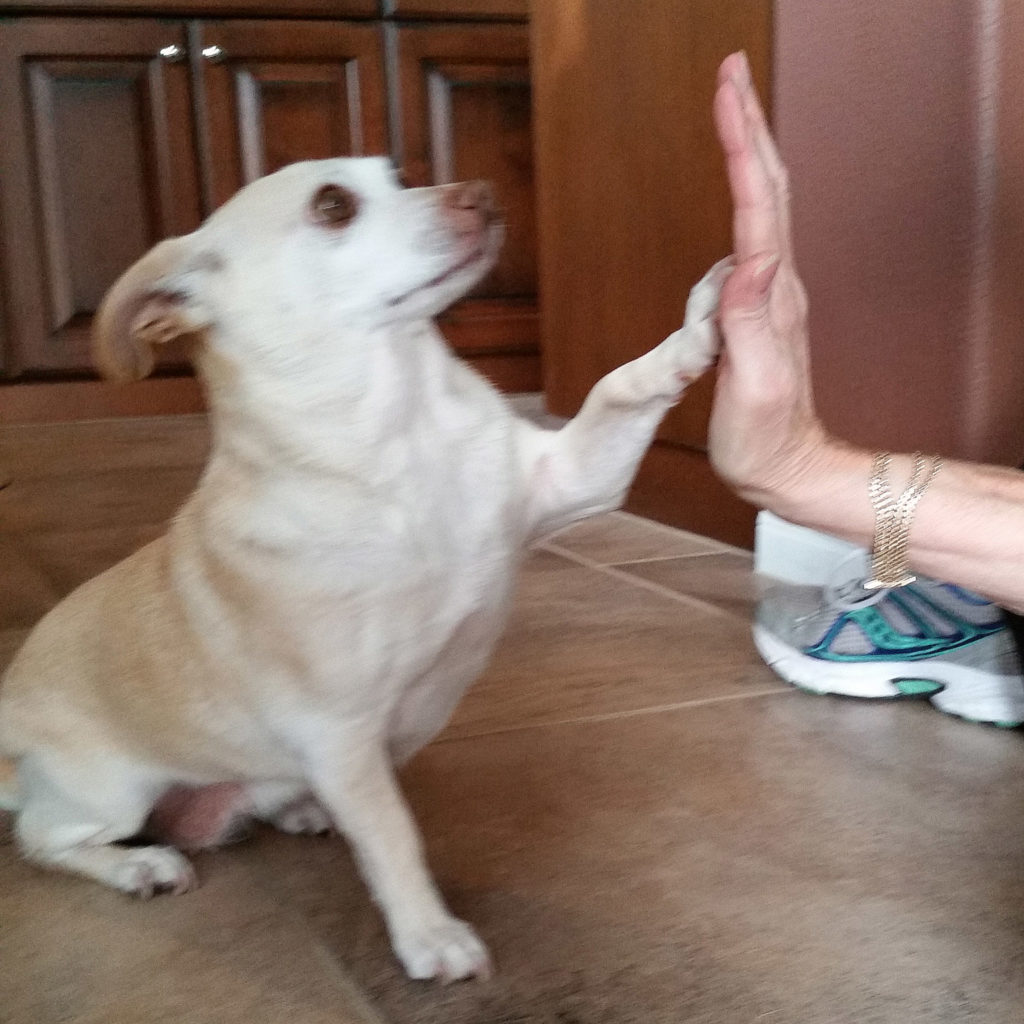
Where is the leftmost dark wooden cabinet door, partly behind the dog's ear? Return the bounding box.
[0,17,200,377]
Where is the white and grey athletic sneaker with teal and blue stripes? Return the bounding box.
[754,577,1024,729]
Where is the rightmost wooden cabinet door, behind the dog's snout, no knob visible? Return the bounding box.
[396,25,540,390]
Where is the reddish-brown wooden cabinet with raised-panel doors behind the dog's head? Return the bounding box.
[0,0,540,417]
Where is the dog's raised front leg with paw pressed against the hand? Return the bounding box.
[524,260,731,537]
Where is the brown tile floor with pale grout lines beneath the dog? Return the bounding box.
[0,418,1024,1024]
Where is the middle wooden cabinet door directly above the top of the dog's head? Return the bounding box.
[196,20,388,209]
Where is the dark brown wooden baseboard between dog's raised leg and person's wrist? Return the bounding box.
[626,441,757,550]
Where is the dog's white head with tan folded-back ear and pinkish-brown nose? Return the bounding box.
[93,158,503,380]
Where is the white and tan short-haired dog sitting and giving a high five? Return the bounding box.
[0,159,727,979]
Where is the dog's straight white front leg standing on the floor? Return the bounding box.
[310,733,490,981]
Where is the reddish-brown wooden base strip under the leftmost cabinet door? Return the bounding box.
[0,377,206,423]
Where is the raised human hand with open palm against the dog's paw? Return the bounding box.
[709,53,830,508]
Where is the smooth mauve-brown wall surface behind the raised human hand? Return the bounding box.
[774,0,1024,464]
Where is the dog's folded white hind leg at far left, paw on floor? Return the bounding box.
[15,756,196,897]
